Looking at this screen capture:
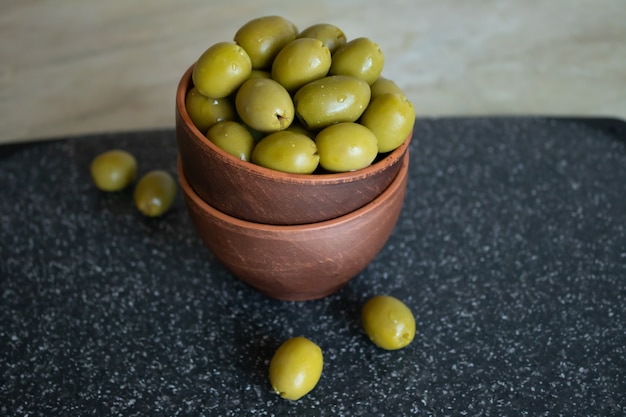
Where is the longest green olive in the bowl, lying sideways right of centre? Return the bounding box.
[293,75,371,130]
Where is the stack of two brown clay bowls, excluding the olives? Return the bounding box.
[176,15,412,301]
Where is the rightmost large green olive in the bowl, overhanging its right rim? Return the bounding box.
[360,93,415,153]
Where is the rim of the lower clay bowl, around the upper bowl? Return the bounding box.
[177,151,409,233]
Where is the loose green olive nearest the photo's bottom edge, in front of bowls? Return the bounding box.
[269,336,324,401]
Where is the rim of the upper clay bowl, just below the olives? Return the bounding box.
[176,63,413,184]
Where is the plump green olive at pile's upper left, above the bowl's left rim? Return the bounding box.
[192,42,252,98]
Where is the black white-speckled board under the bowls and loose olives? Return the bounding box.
[0,117,626,416]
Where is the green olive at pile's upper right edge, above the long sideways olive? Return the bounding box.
[329,38,385,84]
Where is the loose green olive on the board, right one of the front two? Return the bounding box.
[361,295,415,350]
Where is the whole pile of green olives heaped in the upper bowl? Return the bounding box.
[185,15,415,174]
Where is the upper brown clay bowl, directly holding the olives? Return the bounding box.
[176,66,411,225]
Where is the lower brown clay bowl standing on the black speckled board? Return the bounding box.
[178,153,408,301]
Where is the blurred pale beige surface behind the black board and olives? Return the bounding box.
[0,0,626,143]
